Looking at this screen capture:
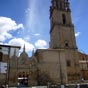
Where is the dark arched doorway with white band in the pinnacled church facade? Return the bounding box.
[18,72,28,87]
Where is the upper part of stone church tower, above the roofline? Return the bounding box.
[50,0,77,49]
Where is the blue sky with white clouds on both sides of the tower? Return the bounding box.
[0,0,88,54]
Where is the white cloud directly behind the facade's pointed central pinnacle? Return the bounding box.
[8,38,34,52]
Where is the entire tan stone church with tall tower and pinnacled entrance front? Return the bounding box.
[0,0,88,86]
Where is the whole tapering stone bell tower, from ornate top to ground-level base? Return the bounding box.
[50,0,80,81]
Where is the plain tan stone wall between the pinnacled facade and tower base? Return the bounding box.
[36,49,67,85]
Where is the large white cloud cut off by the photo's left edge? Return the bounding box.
[0,17,24,42]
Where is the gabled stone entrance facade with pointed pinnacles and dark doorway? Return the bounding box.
[8,47,37,86]
